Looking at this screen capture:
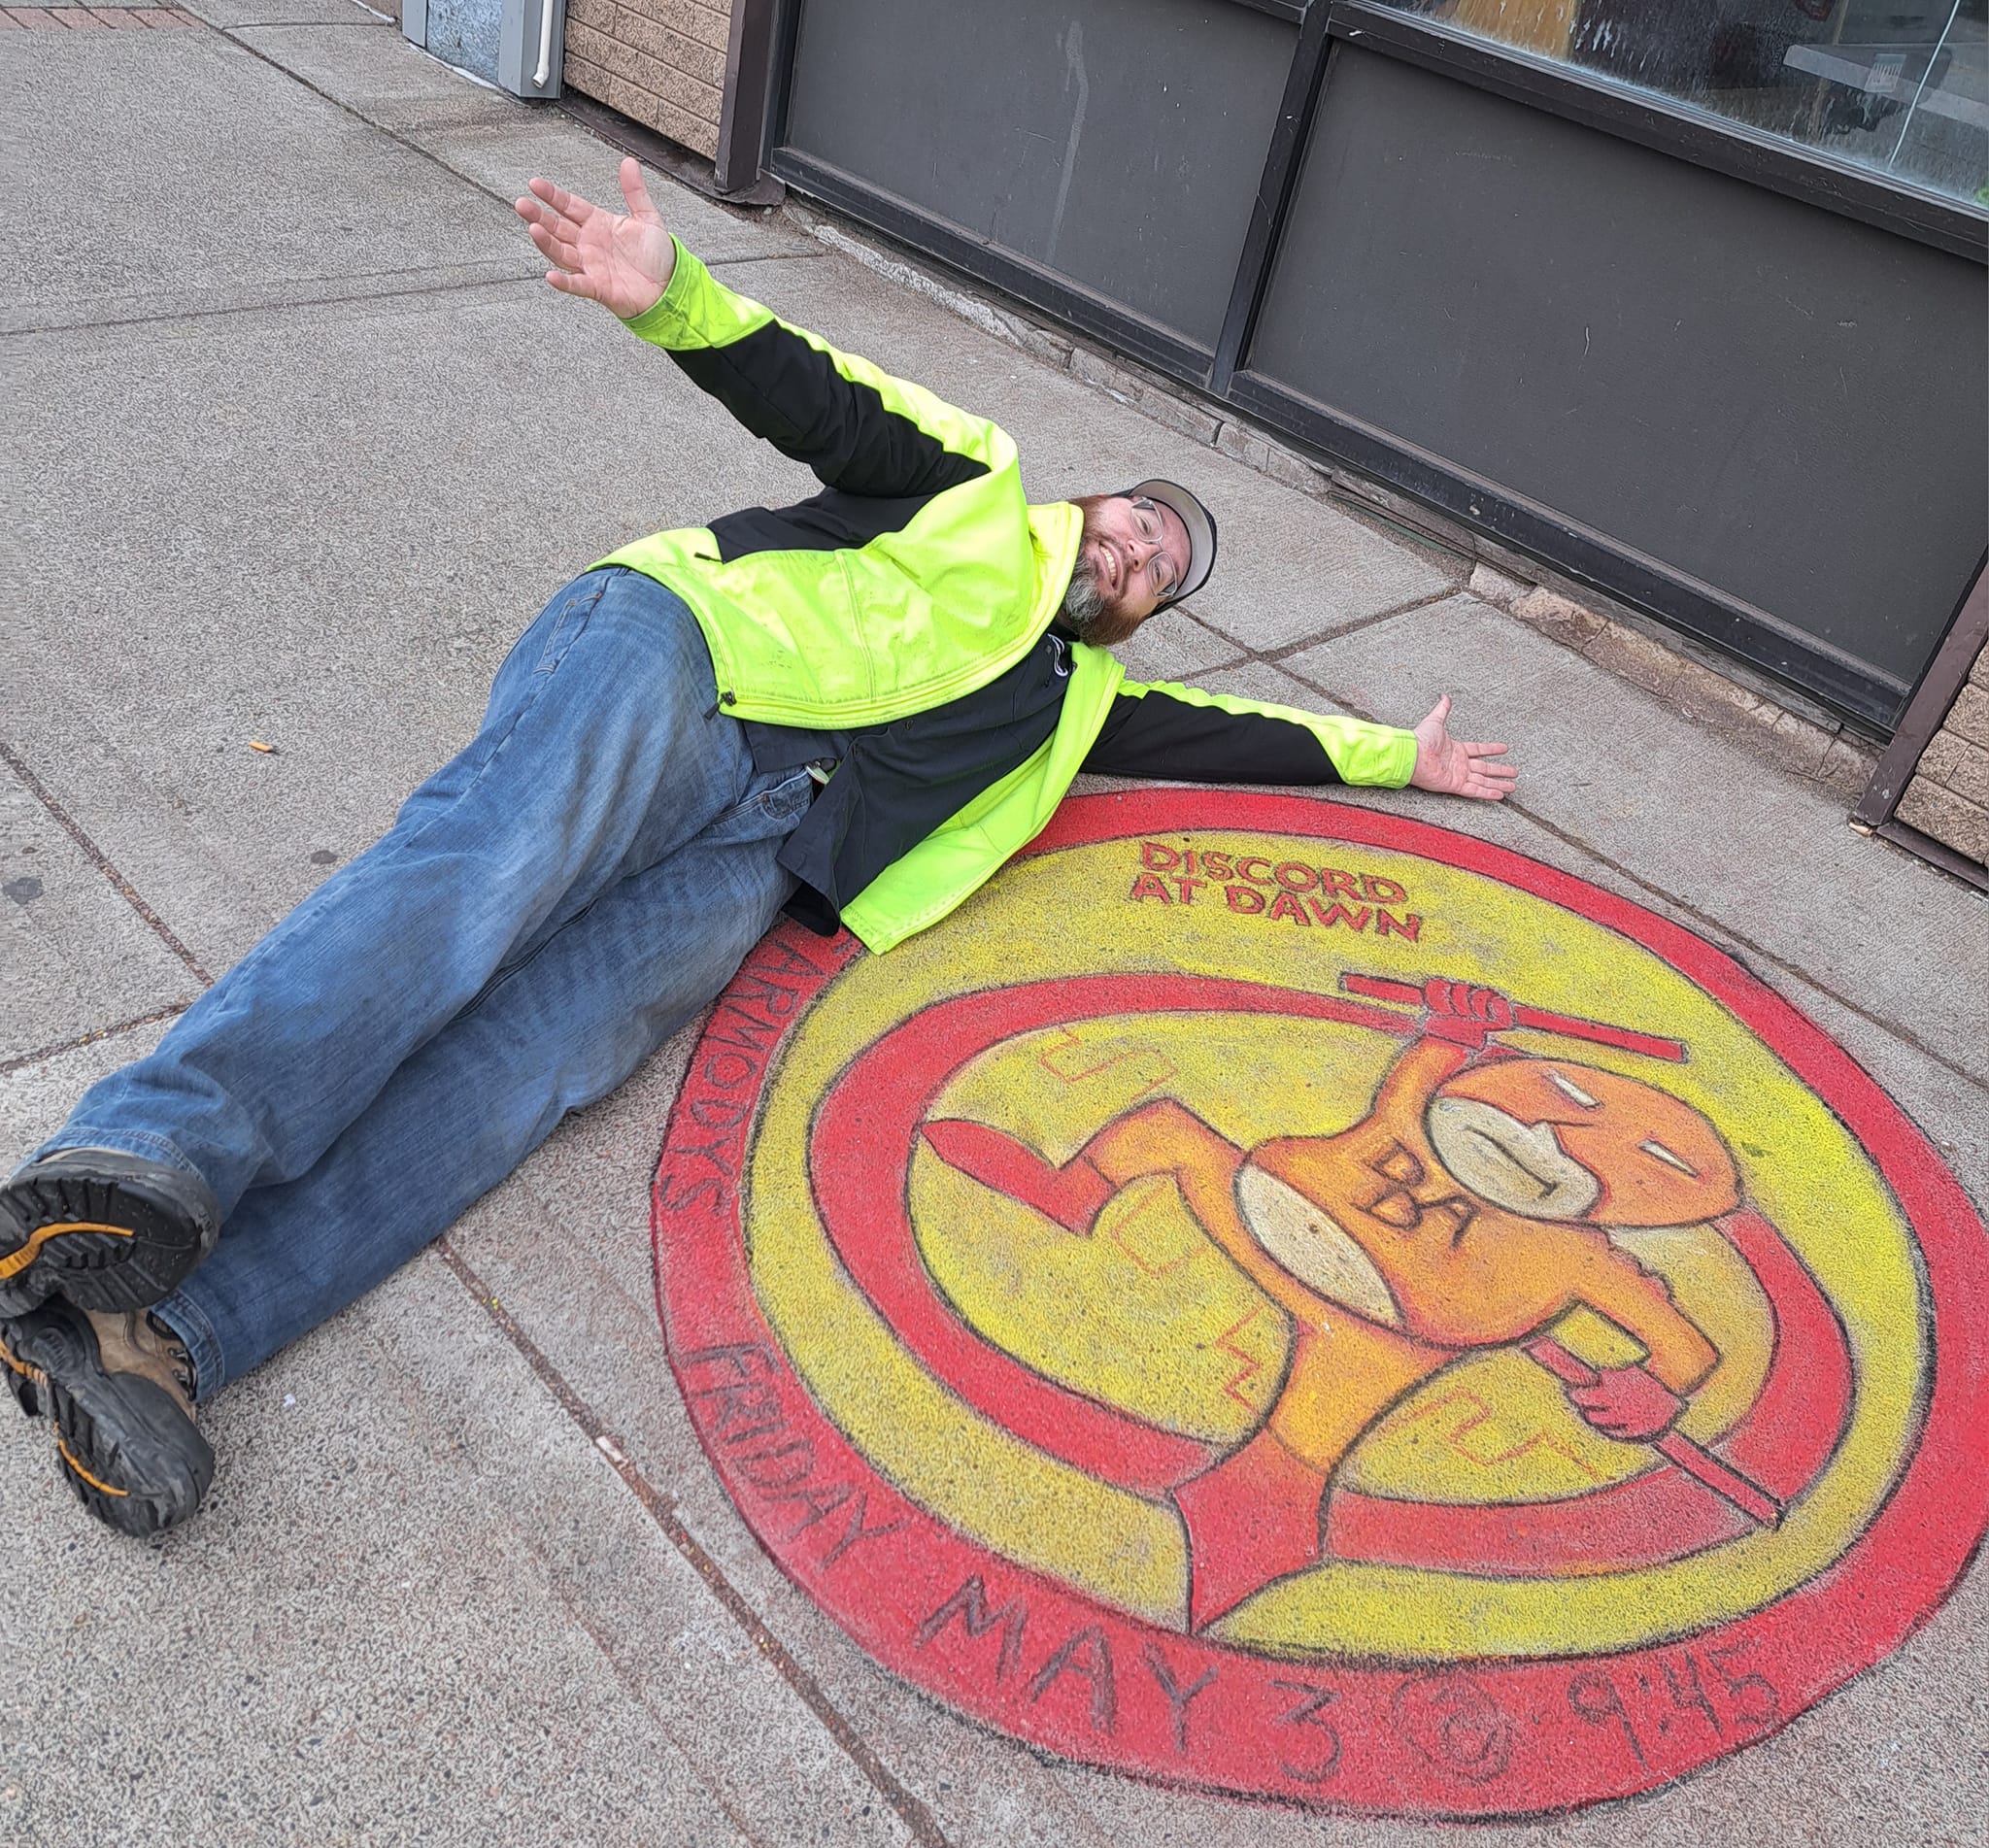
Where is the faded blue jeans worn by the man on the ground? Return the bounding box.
[44,569,810,1398]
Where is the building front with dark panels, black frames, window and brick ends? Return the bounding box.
[399,0,1989,857]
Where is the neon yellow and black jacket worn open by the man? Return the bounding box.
[600,243,1416,951]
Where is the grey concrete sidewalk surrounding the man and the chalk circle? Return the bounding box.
[0,0,1989,1848]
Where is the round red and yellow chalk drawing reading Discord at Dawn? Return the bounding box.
[655,790,1989,1818]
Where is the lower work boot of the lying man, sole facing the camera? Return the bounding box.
[0,1299,215,1535]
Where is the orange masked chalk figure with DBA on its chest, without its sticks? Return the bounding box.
[925,981,1740,1630]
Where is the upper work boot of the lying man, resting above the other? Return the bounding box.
[0,1148,220,1315]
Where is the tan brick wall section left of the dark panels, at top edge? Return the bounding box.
[565,0,732,159]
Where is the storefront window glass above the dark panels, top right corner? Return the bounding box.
[1382,0,1989,209]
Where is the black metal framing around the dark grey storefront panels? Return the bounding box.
[748,0,1989,736]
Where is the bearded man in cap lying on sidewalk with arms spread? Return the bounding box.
[0,161,1514,1533]
